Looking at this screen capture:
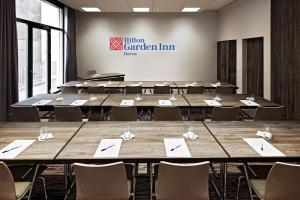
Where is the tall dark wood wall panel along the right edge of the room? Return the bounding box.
[271,0,300,120]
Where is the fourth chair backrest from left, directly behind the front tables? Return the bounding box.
[153,107,182,121]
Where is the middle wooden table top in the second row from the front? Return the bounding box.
[102,94,189,107]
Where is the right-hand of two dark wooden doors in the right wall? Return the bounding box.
[243,37,264,97]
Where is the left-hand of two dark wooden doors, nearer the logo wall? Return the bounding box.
[217,40,236,85]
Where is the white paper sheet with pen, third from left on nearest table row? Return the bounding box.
[164,138,191,158]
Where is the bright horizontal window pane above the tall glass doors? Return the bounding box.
[16,0,62,28]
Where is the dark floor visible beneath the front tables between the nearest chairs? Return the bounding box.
[12,165,268,200]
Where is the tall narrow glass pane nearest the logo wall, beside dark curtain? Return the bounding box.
[51,30,63,92]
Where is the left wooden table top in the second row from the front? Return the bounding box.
[13,93,109,107]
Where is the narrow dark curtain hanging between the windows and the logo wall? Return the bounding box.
[66,8,77,82]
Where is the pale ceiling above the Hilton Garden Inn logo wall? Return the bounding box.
[59,0,234,12]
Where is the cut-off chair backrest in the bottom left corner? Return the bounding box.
[0,162,17,200]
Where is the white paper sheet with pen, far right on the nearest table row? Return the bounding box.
[243,138,285,157]
